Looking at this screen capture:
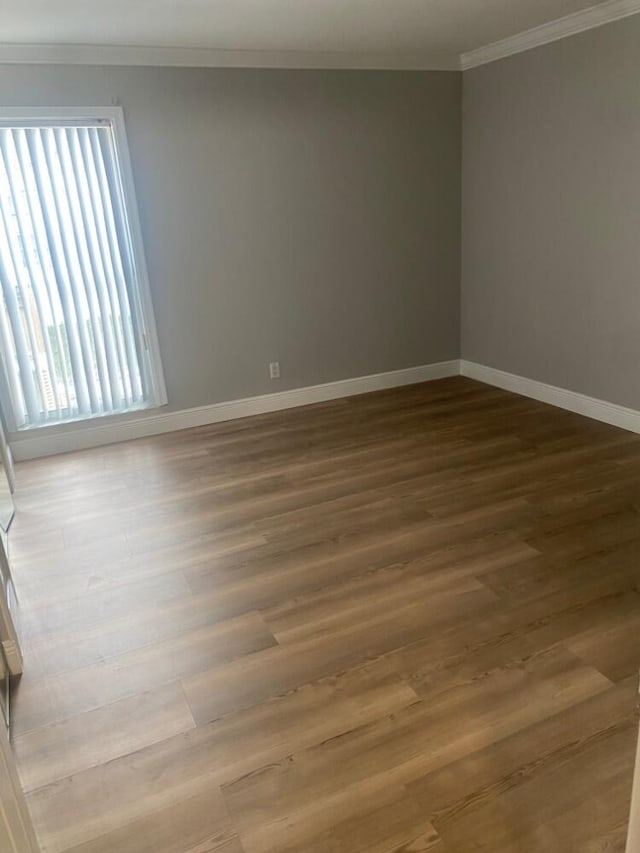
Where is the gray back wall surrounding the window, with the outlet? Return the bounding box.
[0,66,461,409]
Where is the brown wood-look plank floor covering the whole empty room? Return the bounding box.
[6,378,640,853]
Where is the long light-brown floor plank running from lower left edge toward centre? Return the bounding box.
[22,667,418,844]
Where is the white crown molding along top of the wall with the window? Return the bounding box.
[0,43,460,71]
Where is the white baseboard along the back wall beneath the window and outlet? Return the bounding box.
[10,359,460,461]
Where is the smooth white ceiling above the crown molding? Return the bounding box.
[0,0,636,67]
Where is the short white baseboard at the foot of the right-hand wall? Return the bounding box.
[460,359,640,433]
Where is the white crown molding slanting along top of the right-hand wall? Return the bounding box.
[460,0,640,71]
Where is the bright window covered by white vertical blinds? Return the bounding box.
[0,108,166,429]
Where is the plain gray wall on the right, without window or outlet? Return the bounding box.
[462,16,640,408]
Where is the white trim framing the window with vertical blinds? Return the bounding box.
[0,106,168,433]
